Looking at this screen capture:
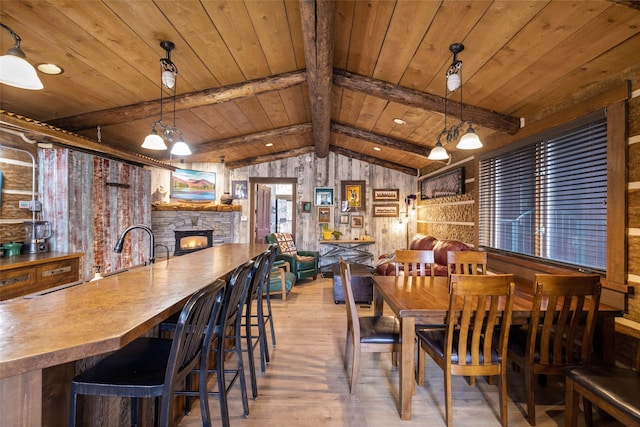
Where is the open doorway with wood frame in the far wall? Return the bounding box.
[249,178,298,243]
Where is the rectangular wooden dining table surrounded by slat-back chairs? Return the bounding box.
[373,275,622,420]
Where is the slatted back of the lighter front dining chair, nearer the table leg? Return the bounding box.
[445,274,515,375]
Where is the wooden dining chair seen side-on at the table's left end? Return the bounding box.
[340,257,401,394]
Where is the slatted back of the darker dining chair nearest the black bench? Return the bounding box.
[527,274,600,366]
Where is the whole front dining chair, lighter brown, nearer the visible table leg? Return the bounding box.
[416,274,515,426]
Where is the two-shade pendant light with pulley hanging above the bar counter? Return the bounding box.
[142,40,191,156]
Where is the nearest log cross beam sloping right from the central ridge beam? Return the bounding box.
[333,70,520,135]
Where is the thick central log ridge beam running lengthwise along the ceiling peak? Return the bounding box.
[300,0,335,158]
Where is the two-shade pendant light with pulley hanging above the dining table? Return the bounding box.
[427,43,482,160]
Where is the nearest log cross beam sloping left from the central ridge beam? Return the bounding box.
[50,71,307,132]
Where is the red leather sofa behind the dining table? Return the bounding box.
[375,234,471,276]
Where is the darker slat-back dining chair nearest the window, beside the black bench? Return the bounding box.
[508,274,600,426]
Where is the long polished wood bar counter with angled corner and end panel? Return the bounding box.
[0,244,268,426]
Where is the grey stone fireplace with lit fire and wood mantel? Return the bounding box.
[151,204,242,255]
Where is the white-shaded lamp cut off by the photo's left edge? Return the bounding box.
[0,22,44,90]
